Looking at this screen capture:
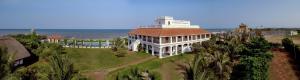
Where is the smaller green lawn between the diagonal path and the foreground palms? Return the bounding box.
[106,54,193,80]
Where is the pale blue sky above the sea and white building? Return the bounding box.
[0,0,300,29]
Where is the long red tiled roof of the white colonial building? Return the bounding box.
[128,28,209,36]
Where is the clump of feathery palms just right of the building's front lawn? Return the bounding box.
[185,37,231,80]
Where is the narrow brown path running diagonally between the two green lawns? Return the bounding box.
[87,56,156,80]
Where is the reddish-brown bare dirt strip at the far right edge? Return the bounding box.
[269,50,299,80]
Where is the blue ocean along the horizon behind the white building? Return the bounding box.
[0,29,231,39]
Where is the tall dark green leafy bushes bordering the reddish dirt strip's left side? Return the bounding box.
[231,37,273,80]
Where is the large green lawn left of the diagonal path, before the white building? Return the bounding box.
[65,48,150,72]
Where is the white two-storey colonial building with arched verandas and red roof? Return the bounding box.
[128,16,211,58]
